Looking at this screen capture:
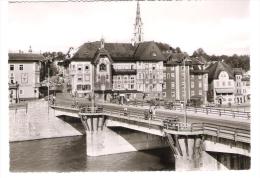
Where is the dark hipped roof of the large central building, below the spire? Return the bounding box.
[72,41,165,62]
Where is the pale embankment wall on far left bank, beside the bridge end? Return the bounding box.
[9,100,82,142]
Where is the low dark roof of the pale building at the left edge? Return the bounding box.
[8,53,45,61]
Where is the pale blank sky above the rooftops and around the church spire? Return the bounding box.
[8,0,250,55]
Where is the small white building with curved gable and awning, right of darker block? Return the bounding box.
[207,61,235,105]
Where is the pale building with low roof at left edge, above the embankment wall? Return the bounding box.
[8,52,44,102]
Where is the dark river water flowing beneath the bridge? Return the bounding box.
[10,136,175,172]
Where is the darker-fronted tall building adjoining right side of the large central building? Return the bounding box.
[163,53,208,104]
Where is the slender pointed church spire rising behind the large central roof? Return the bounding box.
[133,1,143,44]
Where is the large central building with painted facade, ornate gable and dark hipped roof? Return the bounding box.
[70,40,164,98]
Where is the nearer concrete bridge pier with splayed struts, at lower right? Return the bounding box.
[166,134,250,171]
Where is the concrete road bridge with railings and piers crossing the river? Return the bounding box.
[52,104,250,170]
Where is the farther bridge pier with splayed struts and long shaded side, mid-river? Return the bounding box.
[81,116,168,156]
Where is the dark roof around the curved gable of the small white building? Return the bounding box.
[206,61,234,83]
